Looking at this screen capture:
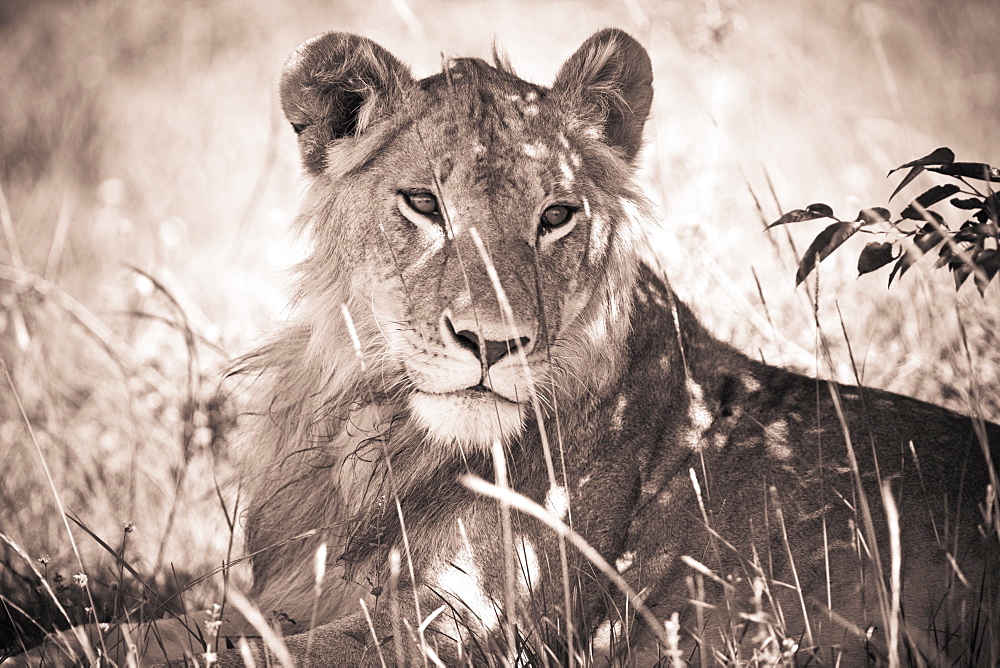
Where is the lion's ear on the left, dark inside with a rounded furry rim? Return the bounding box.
[281,32,413,174]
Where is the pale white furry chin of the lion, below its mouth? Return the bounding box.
[409,390,524,450]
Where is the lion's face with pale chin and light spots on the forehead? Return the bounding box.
[282,30,648,447]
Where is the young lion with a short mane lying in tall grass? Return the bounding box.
[9,30,1000,666]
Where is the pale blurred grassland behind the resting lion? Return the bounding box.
[0,0,1000,647]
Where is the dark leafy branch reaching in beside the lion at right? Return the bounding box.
[768,147,1000,294]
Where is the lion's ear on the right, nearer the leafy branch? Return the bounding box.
[552,28,653,162]
